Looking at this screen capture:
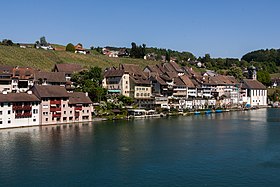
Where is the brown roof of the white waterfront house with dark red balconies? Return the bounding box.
[0,93,40,103]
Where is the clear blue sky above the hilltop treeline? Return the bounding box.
[0,0,280,58]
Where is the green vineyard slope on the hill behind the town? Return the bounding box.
[0,45,159,71]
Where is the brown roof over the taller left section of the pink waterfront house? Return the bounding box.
[31,85,69,98]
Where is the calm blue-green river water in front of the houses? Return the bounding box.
[0,109,280,186]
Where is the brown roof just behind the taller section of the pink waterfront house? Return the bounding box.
[34,71,66,83]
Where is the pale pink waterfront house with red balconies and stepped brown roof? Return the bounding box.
[31,85,93,125]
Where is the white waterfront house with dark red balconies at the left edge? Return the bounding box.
[0,91,40,128]
